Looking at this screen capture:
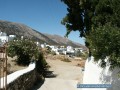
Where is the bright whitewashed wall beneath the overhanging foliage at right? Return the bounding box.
[82,57,120,90]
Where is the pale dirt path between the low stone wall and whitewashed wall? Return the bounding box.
[37,59,82,90]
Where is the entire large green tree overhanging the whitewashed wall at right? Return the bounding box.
[61,0,120,67]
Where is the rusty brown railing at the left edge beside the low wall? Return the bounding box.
[0,46,7,90]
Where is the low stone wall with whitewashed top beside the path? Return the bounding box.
[1,63,37,90]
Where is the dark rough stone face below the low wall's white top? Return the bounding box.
[7,70,37,90]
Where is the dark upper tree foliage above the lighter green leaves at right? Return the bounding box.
[61,0,120,37]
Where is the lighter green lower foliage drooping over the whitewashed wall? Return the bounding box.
[87,24,120,68]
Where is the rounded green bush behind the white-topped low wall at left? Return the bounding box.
[7,40,38,65]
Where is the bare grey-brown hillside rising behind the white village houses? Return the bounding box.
[0,20,84,47]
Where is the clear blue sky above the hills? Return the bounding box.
[0,0,84,45]
